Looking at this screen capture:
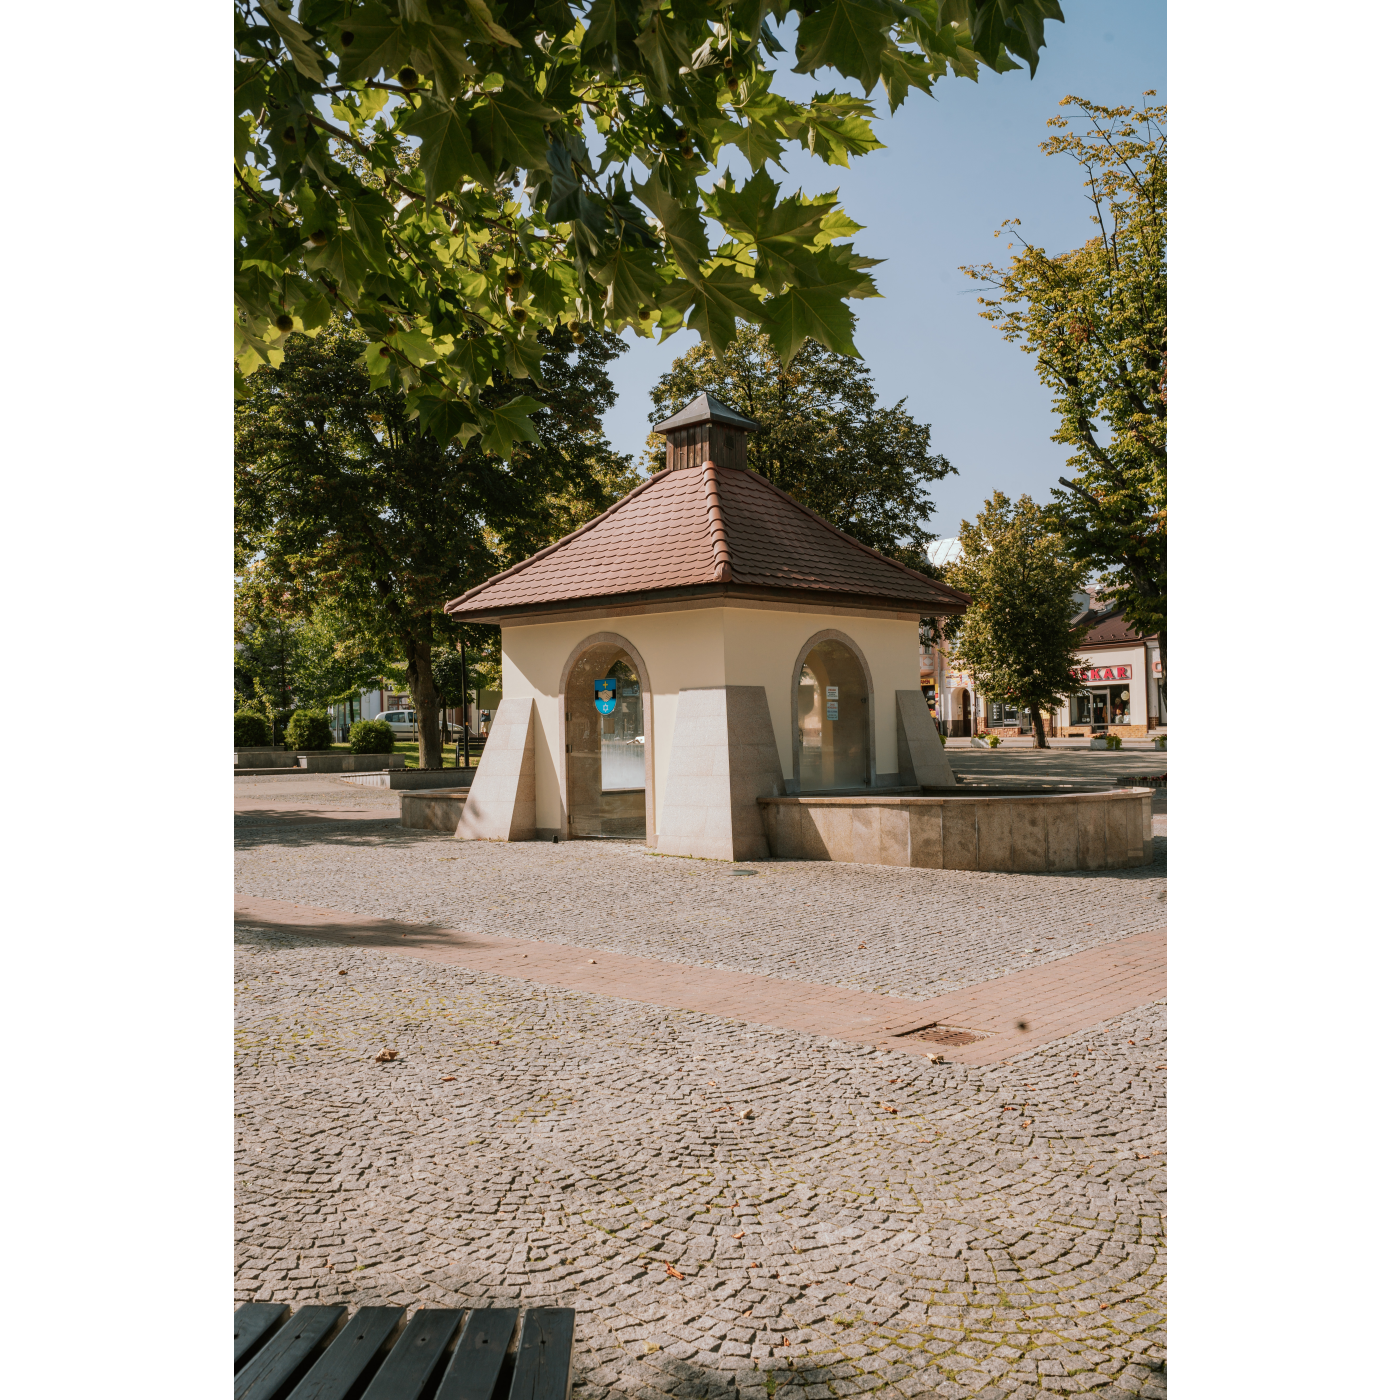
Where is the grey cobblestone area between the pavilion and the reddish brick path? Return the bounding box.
[237,823,1166,1000]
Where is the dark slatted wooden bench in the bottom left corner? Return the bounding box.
[234,1303,574,1400]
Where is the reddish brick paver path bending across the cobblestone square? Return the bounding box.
[234,895,1166,1064]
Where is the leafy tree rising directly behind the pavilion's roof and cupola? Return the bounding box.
[651,326,956,574]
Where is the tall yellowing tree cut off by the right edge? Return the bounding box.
[963,92,1166,676]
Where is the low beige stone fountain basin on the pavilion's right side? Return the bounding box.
[759,787,1152,872]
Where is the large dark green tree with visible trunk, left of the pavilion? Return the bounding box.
[234,325,636,769]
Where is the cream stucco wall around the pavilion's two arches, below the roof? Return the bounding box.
[501,608,918,829]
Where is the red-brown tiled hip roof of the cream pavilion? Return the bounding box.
[447,462,966,619]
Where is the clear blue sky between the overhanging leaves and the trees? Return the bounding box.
[605,0,1168,535]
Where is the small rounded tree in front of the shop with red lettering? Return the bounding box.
[946,491,1085,749]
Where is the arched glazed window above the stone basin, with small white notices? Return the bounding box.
[792,634,871,792]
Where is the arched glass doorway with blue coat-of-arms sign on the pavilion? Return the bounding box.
[564,643,647,840]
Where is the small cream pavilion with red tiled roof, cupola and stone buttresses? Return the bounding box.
[447,393,967,860]
